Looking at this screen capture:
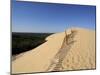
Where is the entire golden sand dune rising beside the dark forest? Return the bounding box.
[12,28,96,74]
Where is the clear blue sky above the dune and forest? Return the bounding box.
[12,0,96,32]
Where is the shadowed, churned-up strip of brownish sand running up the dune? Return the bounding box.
[46,30,76,71]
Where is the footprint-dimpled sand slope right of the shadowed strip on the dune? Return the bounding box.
[62,29,95,70]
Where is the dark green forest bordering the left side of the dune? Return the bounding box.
[12,32,53,55]
